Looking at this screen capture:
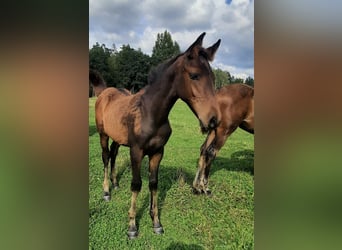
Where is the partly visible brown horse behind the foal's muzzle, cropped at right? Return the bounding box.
[193,84,254,195]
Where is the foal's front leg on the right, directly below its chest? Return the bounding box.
[149,148,164,234]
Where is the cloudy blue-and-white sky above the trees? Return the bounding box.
[89,0,254,79]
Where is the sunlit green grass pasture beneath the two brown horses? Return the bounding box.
[89,98,254,250]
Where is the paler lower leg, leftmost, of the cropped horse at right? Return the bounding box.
[192,130,216,194]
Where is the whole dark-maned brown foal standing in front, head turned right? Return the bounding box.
[89,33,221,239]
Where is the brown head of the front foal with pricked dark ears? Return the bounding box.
[176,32,221,132]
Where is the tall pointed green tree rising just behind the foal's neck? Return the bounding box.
[152,30,180,66]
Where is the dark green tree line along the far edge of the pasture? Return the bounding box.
[89,31,254,97]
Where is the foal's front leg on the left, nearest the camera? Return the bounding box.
[127,148,143,239]
